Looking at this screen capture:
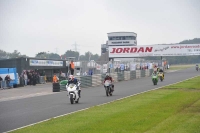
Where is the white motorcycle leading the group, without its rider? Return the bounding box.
[66,82,81,104]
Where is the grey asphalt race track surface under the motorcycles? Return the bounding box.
[0,68,200,132]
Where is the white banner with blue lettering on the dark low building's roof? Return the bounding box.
[29,59,63,66]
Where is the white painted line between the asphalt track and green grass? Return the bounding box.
[4,76,198,133]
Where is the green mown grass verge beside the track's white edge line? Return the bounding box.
[14,77,200,133]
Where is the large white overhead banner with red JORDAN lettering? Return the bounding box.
[109,44,200,58]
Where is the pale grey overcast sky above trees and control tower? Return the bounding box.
[0,0,200,57]
